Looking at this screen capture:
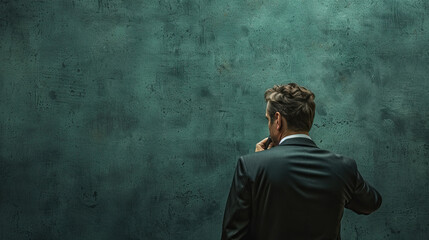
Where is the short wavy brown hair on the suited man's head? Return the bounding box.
[264,83,316,132]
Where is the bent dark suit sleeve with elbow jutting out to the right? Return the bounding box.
[345,161,382,215]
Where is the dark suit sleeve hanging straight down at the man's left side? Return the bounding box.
[222,157,251,240]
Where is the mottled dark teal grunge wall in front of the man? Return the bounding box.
[0,0,429,240]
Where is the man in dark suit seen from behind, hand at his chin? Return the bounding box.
[222,83,382,240]
